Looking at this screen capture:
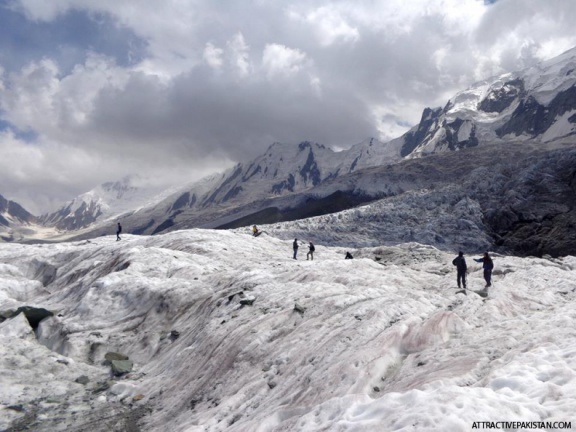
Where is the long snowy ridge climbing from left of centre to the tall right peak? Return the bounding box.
[80,49,576,243]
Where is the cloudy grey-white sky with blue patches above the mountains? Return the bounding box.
[0,0,576,214]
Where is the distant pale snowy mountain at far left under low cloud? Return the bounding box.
[40,176,172,230]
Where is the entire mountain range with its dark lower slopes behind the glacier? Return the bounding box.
[11,49,576,255]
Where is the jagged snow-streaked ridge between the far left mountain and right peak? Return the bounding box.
[59,138,399,238]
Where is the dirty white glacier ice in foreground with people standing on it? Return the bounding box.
[0,228,576,432]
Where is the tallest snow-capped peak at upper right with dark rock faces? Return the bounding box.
[401,48,576,157]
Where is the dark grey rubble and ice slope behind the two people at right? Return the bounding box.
[245,139,576,257]
